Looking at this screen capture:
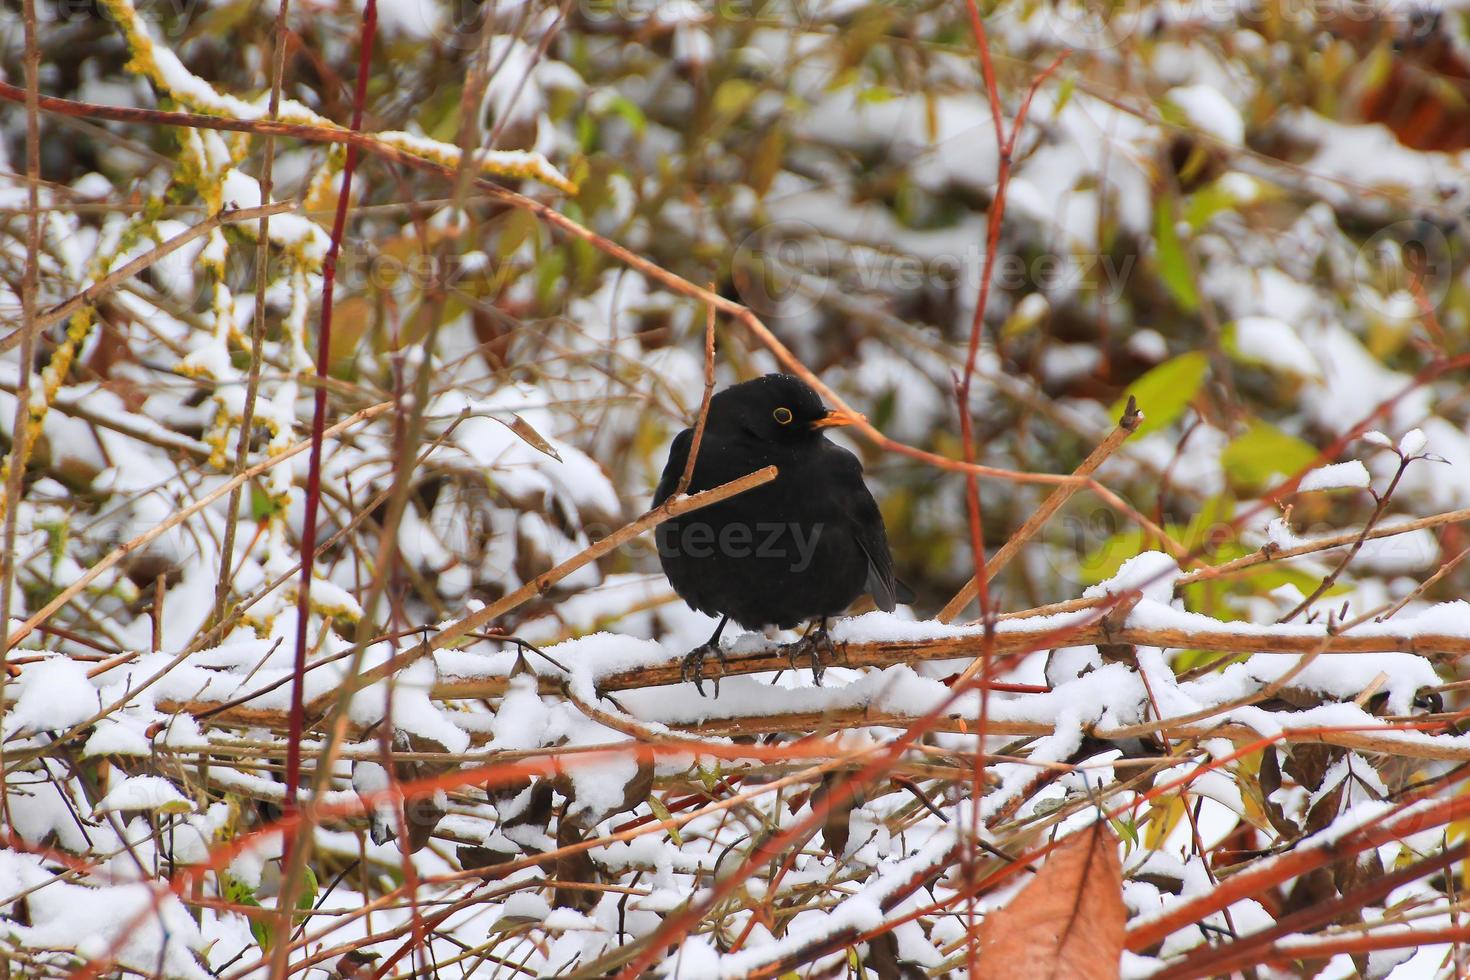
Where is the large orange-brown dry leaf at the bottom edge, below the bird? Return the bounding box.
[975,820,1127,980]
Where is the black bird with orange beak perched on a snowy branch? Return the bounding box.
[653,375,913,695]
